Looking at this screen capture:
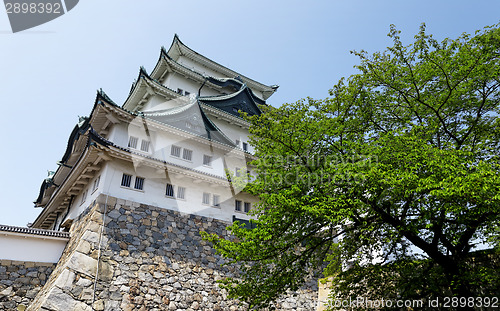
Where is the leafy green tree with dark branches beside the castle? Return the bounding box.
[202,25,500,309]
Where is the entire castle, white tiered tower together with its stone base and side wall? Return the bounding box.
[0,36,317,311]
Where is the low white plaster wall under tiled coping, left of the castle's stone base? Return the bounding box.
[0,232,67,263]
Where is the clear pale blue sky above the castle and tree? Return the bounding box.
[0,0,500,226]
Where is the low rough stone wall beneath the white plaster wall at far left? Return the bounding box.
[0,260,56,310]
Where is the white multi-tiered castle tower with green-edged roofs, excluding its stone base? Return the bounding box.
[33,35,277,230]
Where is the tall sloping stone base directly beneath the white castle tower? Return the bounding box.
[28,197,317,311]
